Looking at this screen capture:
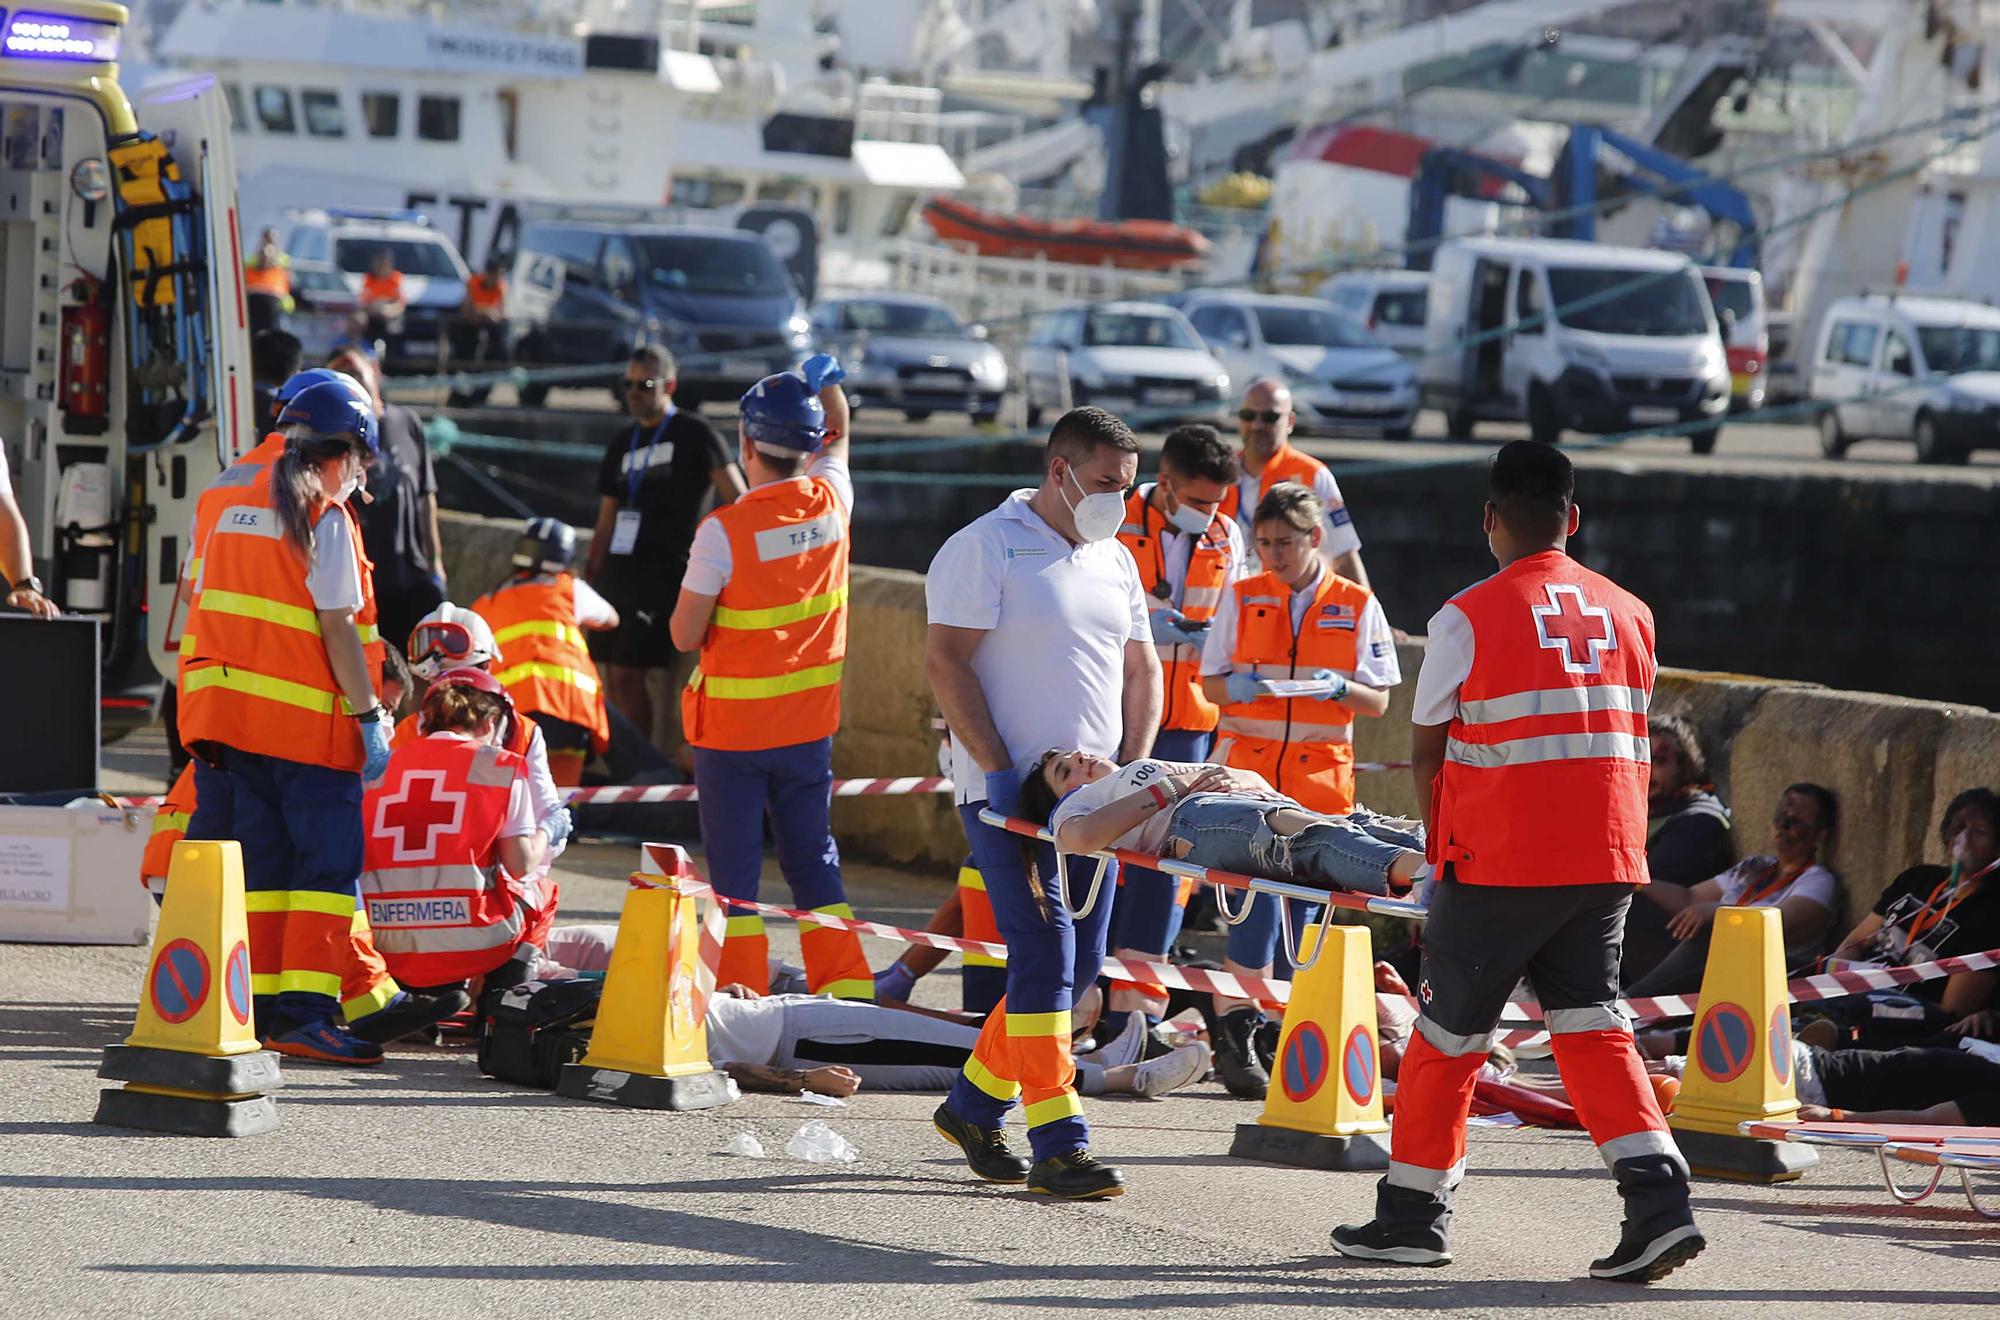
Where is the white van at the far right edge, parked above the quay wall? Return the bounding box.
[1806,294,2000,464]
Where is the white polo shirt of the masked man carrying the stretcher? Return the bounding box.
[924,490,1152,802]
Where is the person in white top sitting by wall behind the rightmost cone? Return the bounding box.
[1628,784,1840,998]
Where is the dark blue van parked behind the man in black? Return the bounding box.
[510,220,812,408]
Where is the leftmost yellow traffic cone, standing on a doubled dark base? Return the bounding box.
[96,840,284,1136]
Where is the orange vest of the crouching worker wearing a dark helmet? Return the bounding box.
[472,572,612,752]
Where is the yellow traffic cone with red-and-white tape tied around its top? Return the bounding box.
[556,844,734,1110]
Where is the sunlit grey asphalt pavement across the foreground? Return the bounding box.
[0,734,2000,1320]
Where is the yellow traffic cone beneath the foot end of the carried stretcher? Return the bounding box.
[1230,896,1388,1170]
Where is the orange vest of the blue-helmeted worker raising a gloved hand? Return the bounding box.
[680,476,848,752]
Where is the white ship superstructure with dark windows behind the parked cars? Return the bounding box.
[156,0,964,264]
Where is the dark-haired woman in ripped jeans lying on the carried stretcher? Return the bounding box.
[1020,748,1424,894]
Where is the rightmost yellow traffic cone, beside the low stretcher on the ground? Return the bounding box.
[1668,908,1820,1182]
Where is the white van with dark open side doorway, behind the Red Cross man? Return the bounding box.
[1418,238,1730,454]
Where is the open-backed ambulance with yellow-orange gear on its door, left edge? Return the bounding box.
[0,0,260,734]
